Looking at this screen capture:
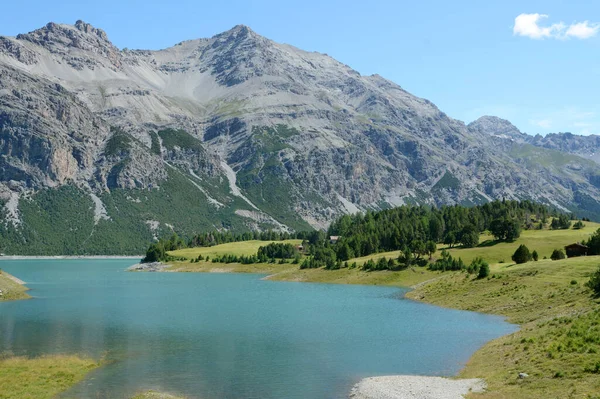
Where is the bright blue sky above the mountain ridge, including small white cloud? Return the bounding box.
[0,0,600,134]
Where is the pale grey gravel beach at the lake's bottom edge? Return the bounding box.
[350,375,485,399]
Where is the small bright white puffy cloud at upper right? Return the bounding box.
[513,13,600,40]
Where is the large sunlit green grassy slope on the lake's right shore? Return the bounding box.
[407,256,600,399]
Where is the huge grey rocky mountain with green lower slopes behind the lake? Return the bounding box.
[0,21,600,254]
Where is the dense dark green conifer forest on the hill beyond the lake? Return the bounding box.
[322,201,556,261]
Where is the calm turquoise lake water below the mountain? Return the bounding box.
[0,259,516,399]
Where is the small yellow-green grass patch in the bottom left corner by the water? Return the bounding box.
[0,355,100,399]
